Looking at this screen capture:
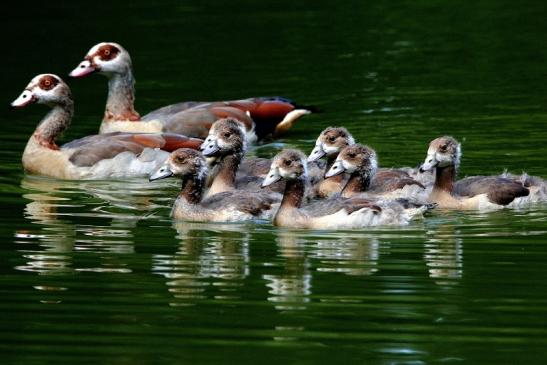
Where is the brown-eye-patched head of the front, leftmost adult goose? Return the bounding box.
[11,74,72,108]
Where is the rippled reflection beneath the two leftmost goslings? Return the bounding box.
[152,222,254,306]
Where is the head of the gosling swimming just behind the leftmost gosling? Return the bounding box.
[200,118,247,157]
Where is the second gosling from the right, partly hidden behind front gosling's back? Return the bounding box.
[325,144,427,203]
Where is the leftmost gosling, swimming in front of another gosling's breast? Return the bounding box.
[150,148,278,222]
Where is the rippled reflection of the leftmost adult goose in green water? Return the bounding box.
[14,176,163,300]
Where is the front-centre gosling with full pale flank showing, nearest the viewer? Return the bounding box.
[262,149,428,229]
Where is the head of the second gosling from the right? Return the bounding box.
[325,144,378,178]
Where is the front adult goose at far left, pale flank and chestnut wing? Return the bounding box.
[11,74,202,179]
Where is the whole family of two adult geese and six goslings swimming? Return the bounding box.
[11,42,547,229]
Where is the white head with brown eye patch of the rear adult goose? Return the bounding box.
[69,42,131,78]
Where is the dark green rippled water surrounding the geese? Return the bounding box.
[0,0,547,364]
